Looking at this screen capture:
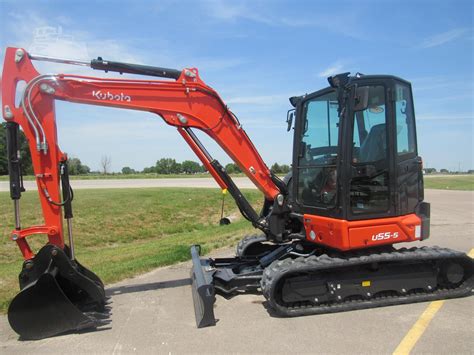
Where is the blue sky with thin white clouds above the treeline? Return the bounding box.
[0,0,474,171]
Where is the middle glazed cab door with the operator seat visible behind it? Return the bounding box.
[346,84,395,220]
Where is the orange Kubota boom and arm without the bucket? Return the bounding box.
[2,48,285,260]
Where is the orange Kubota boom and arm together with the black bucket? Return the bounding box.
[1,48,290,339]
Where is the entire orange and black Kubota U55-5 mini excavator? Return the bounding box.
[2,48,474,339]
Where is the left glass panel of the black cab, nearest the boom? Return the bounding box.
[292,89,342,218]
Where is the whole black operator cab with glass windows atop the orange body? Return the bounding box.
[290,73,423,220]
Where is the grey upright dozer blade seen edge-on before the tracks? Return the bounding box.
[191,245,216,328]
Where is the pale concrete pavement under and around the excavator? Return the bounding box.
[0,190,474,354]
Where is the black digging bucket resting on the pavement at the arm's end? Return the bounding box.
[8,245,109,340]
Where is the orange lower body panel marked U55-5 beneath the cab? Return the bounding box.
[304,214,421,250]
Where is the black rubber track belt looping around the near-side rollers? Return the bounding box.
[261,247,474,317]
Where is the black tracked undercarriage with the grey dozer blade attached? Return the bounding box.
[192,237,474,327]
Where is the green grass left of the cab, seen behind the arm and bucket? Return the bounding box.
[0,188,262,312]
